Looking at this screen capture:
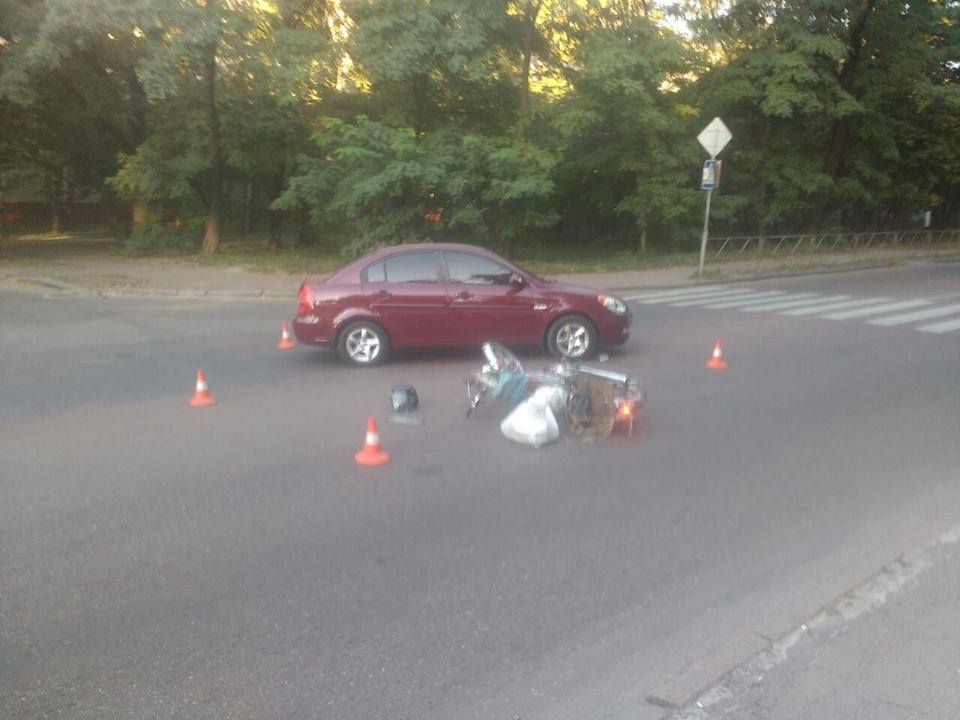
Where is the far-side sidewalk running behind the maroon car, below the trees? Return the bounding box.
[0,246,960,298]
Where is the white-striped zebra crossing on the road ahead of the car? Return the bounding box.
[623,285,960,334]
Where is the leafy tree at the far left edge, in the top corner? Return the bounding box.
[0,0,146,229]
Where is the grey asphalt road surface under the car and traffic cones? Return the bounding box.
[0,264,960,720]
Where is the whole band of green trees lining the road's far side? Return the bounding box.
[0,0,960,253]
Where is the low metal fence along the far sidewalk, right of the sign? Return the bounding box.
[708,228,960,258]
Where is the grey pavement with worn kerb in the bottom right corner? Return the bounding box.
[670,529,960,720]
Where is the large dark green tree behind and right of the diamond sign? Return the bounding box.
[691,0,957,232]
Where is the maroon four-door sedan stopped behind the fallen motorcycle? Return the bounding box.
[293,244,631,365]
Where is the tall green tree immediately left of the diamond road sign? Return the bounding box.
[554,2,697,250]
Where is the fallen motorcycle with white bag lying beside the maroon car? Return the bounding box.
[466,342,646,447]
